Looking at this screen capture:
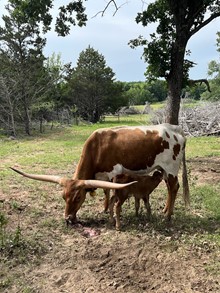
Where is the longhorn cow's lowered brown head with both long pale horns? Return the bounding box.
[11,168,136,224]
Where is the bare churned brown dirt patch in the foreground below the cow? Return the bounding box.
[10,231,219,293]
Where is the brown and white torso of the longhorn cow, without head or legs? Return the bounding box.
[77,124,185,179]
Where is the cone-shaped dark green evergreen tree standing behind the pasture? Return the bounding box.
[70,46,115,123]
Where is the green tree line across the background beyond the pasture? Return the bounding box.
[0,1,220,136]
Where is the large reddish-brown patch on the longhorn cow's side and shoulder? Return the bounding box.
[74,128,169,179]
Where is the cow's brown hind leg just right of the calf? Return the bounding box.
[163,174,179,220]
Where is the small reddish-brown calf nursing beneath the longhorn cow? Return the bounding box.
[109,171,163,230]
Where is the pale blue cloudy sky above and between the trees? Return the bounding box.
[0,0,220,81]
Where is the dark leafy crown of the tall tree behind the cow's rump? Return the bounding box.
[130,0,220,83]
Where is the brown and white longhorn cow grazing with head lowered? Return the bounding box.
[10,123,189,222]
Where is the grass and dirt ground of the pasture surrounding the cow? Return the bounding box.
[0,115,220,293]
